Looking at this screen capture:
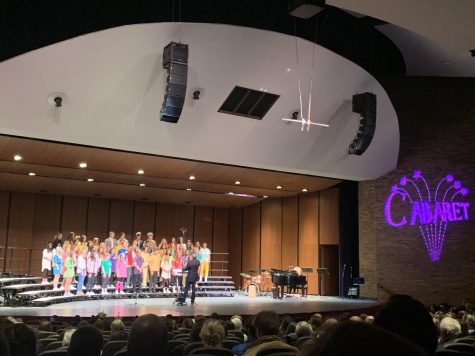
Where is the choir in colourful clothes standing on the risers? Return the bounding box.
[41,231,211,296]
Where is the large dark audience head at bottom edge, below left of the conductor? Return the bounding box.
[127,314,168,356]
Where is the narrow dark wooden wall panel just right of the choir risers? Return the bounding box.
[228,209,242,287]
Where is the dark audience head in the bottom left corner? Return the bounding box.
[5,323,36,356]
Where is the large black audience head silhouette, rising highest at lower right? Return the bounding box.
[374,295,437,354]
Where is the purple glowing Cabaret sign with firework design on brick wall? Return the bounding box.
[384,171,470,262]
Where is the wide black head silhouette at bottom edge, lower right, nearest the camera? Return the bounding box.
[314,322,426,356]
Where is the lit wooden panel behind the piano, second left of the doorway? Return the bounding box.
[281,196,299,269]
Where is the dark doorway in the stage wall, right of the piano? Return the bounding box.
[319,245,340,296]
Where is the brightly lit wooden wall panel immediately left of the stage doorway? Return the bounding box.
[299,193,318,294]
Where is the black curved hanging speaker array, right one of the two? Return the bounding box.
[349,93,376,156]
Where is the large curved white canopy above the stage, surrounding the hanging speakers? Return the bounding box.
[0,23,399,180]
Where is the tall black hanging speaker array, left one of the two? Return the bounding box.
[160,42,188,124]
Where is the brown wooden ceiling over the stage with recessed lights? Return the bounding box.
[0,135,339,207]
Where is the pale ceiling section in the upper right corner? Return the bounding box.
[327,0,475,52]
